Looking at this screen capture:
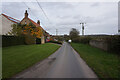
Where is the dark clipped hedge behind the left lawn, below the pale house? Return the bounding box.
[2,35,25,47]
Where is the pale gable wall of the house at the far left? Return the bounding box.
[0,15,14,35]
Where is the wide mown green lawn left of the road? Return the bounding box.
[2,43,60,78]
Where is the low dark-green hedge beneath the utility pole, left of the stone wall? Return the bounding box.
[73,36,92,44]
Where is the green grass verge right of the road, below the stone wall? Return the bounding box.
[71,43,120,78]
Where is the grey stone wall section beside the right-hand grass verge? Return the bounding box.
[89,40,108,51]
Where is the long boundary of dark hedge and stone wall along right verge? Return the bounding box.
[72,35,120,54]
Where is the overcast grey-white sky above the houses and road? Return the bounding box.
[2,2,118,35]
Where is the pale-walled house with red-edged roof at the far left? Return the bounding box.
[0,14,20,35]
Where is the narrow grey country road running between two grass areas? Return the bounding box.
[14,42,97,78]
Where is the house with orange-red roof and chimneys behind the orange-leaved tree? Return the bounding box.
[20,10,50,44]
